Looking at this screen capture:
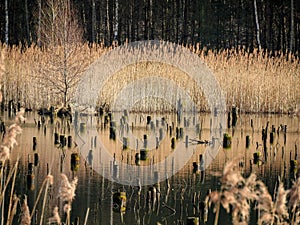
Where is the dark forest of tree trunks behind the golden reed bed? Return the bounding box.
[0,0,300,53]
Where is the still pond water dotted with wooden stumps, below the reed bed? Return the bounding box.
[2,112,300,225]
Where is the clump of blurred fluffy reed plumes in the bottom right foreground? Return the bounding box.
[208,160,300,225]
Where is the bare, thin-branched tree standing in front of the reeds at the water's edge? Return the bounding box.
[38,0,87,106]
